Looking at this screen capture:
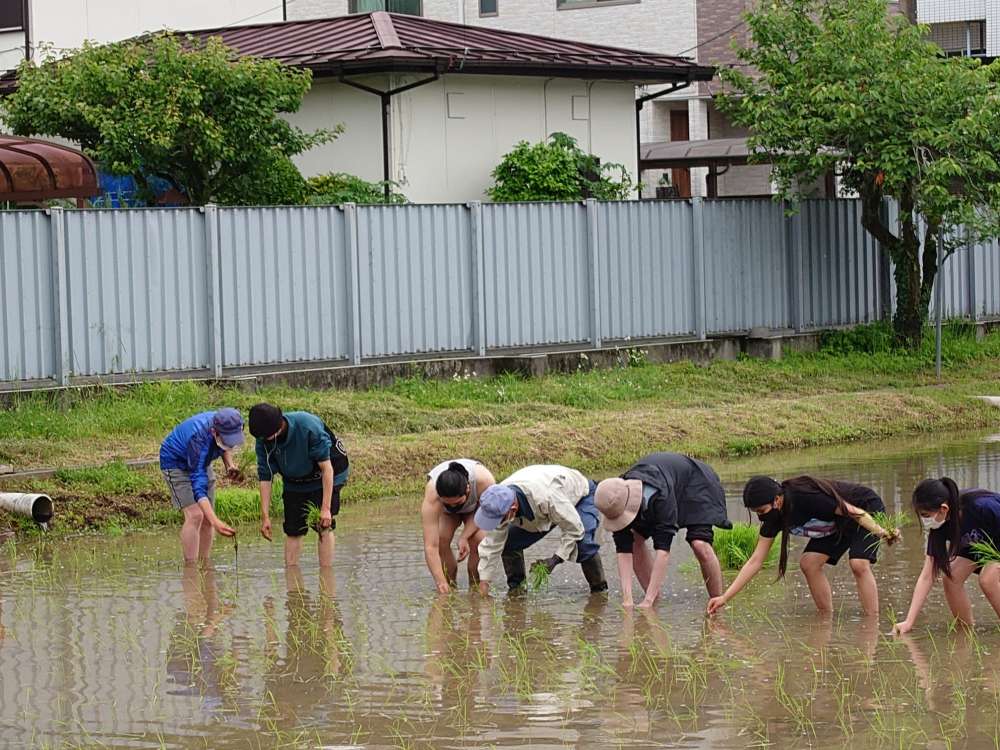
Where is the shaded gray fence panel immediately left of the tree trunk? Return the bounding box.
[791,200,881,328]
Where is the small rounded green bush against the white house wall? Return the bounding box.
[486,133,632,202]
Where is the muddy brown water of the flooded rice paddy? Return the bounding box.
[0,440,1000,749]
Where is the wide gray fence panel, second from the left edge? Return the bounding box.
[65,209,209,375]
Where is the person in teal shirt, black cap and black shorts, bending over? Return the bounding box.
[249,403,350,567]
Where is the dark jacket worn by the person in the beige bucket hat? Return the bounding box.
[622,453,733,529]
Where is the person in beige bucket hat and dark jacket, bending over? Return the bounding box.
[596,453,732,607]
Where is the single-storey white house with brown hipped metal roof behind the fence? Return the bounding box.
[182,12,713,202]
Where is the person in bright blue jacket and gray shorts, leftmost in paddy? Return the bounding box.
[160,407,243,564]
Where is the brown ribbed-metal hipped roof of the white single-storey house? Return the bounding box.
[180,11,714,83]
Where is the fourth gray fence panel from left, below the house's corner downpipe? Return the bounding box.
[358,205,474,357]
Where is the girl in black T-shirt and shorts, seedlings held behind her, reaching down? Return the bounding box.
[708,476,899,615]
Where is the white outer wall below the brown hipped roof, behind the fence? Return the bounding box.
[290,75,636,203]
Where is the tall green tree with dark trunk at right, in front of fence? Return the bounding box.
[720,0,1000,346]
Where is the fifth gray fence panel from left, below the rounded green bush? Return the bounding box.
[483,203,592,349]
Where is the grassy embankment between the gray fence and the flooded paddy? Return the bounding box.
[0,326,1000,531]
